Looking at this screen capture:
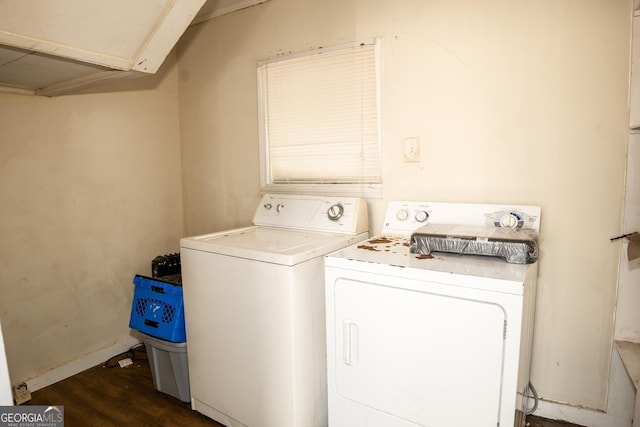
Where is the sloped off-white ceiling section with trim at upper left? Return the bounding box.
[0,0,267,96]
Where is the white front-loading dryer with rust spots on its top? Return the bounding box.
[325,202,540,427]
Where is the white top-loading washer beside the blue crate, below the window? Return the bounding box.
[181,194,368,427]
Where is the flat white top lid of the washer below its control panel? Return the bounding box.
[180,226,368,266]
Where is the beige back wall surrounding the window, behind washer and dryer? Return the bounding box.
[178,0,631,409]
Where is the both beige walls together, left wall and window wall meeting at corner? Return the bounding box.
[0,0,632,409]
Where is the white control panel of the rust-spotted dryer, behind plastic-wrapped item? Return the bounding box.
[382,201,540,236]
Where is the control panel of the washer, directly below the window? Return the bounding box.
[253,194,369,234]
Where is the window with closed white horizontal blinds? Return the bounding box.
[258,40,382,197]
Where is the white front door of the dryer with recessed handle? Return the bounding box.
[333,277,506,427]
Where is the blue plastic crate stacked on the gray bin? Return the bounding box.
[129,275,187,342]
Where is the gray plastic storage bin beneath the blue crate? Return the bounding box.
[141,334,191,402]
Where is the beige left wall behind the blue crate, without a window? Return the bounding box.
[0,55,184,383]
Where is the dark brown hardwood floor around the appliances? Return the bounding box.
[26,347,580,427]
